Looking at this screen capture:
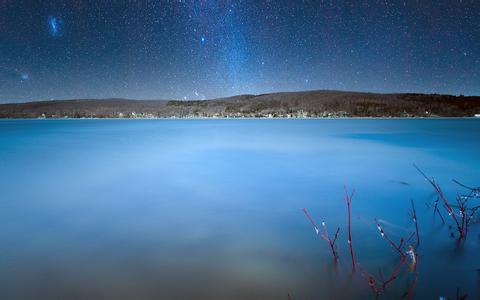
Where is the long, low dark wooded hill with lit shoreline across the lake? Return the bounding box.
[0,91,480,118]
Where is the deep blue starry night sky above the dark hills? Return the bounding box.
[0,0,480,103]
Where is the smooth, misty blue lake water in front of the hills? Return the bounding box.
[0,119,480,299]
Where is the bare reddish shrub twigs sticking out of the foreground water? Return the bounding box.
[302,164,480,300]
